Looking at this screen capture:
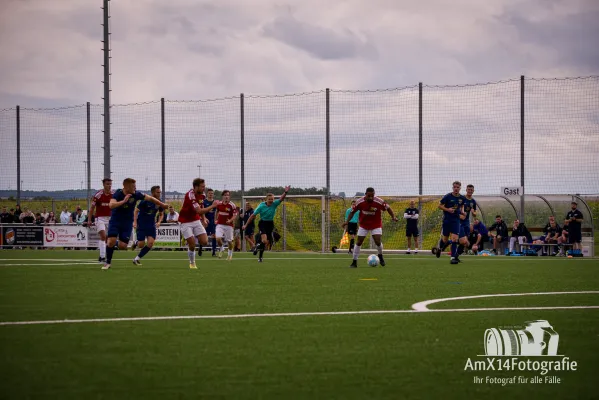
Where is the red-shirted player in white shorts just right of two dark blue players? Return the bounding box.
[179,178,220,269]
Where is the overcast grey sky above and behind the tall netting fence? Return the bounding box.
[0,0,599,194]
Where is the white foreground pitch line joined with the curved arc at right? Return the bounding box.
[0,292,599,326]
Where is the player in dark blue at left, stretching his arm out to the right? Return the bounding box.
[102,178,168,269]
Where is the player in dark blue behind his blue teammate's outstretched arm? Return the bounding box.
[133,186,164,265]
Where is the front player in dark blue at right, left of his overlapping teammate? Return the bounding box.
[433,181,468,264]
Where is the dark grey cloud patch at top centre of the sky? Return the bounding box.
[263,16,378,60]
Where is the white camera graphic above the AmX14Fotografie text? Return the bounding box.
[485,320,559,356]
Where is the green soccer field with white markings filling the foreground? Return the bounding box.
[0,250,599,399]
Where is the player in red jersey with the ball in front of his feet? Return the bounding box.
[343,187,398,268]
